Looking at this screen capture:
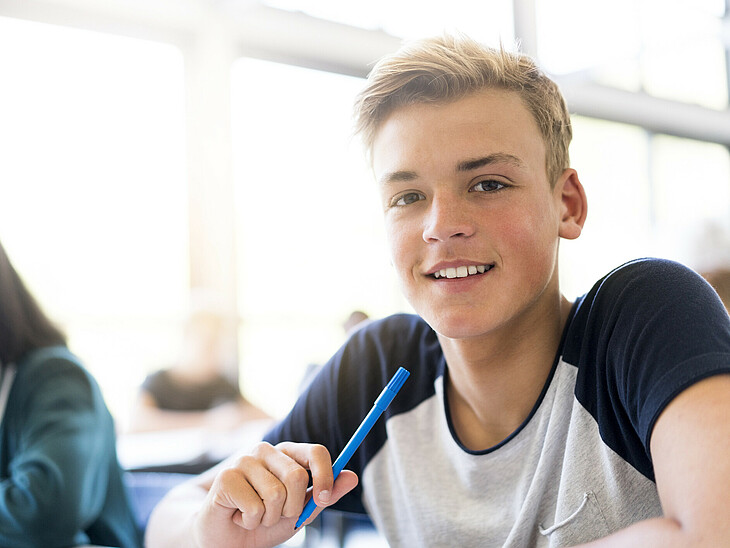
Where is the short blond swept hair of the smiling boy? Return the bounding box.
[355,35,573,185]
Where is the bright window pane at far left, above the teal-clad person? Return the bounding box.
[0,18,188,424]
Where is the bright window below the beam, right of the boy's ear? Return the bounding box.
[560,116,730,298]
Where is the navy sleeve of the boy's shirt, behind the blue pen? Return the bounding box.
[264,314,440,513]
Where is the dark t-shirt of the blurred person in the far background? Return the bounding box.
[142,369,241,411]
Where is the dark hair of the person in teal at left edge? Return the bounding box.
[0,243,66,363]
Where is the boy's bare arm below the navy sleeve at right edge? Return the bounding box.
[586,375,730,548]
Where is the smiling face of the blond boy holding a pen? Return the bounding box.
[373,90,562,338]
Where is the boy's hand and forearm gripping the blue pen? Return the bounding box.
[145,442,357,548]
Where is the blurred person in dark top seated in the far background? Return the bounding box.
[130,294,268,432]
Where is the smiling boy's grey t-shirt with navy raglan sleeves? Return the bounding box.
[266,259,730,548]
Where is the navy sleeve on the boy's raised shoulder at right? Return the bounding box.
[564,259,730,480]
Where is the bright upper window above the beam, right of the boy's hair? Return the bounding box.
[537,0,728,109]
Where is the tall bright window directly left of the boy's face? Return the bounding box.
[232,59,407,414]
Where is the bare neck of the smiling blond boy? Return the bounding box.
[439,295,571,450]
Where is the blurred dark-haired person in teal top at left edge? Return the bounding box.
[0,241,142,548]
